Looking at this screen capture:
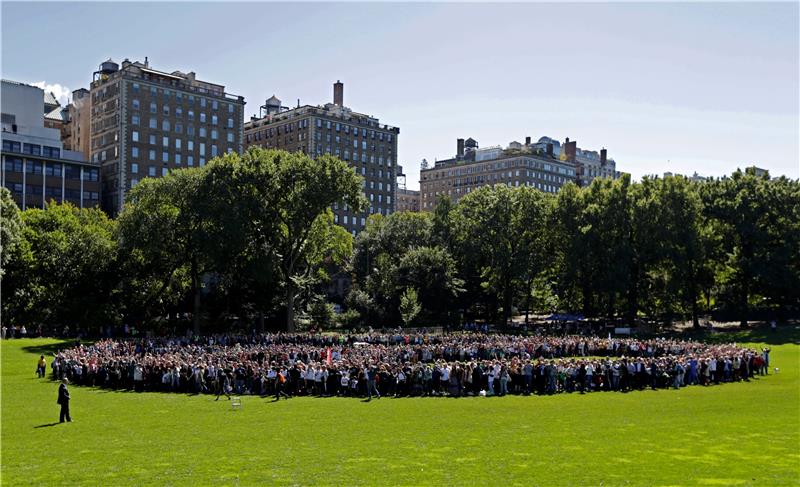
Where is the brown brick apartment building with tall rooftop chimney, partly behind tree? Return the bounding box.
[244,81,400,235]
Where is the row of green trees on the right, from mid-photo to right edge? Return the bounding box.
[348,167,800,326]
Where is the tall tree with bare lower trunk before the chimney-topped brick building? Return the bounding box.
[222,147,366,331]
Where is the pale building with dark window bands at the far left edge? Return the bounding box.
[0,80,100,210]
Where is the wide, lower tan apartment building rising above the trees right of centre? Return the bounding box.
[419,138,577,211]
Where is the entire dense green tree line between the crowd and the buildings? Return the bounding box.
[1,153,800,332]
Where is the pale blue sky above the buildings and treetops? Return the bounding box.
[1,2,800,188]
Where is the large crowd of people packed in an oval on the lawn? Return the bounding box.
[50,332,770,400]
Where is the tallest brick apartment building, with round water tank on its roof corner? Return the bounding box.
[89,58,244,216]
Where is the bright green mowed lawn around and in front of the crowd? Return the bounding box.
[1,330,800,486]
